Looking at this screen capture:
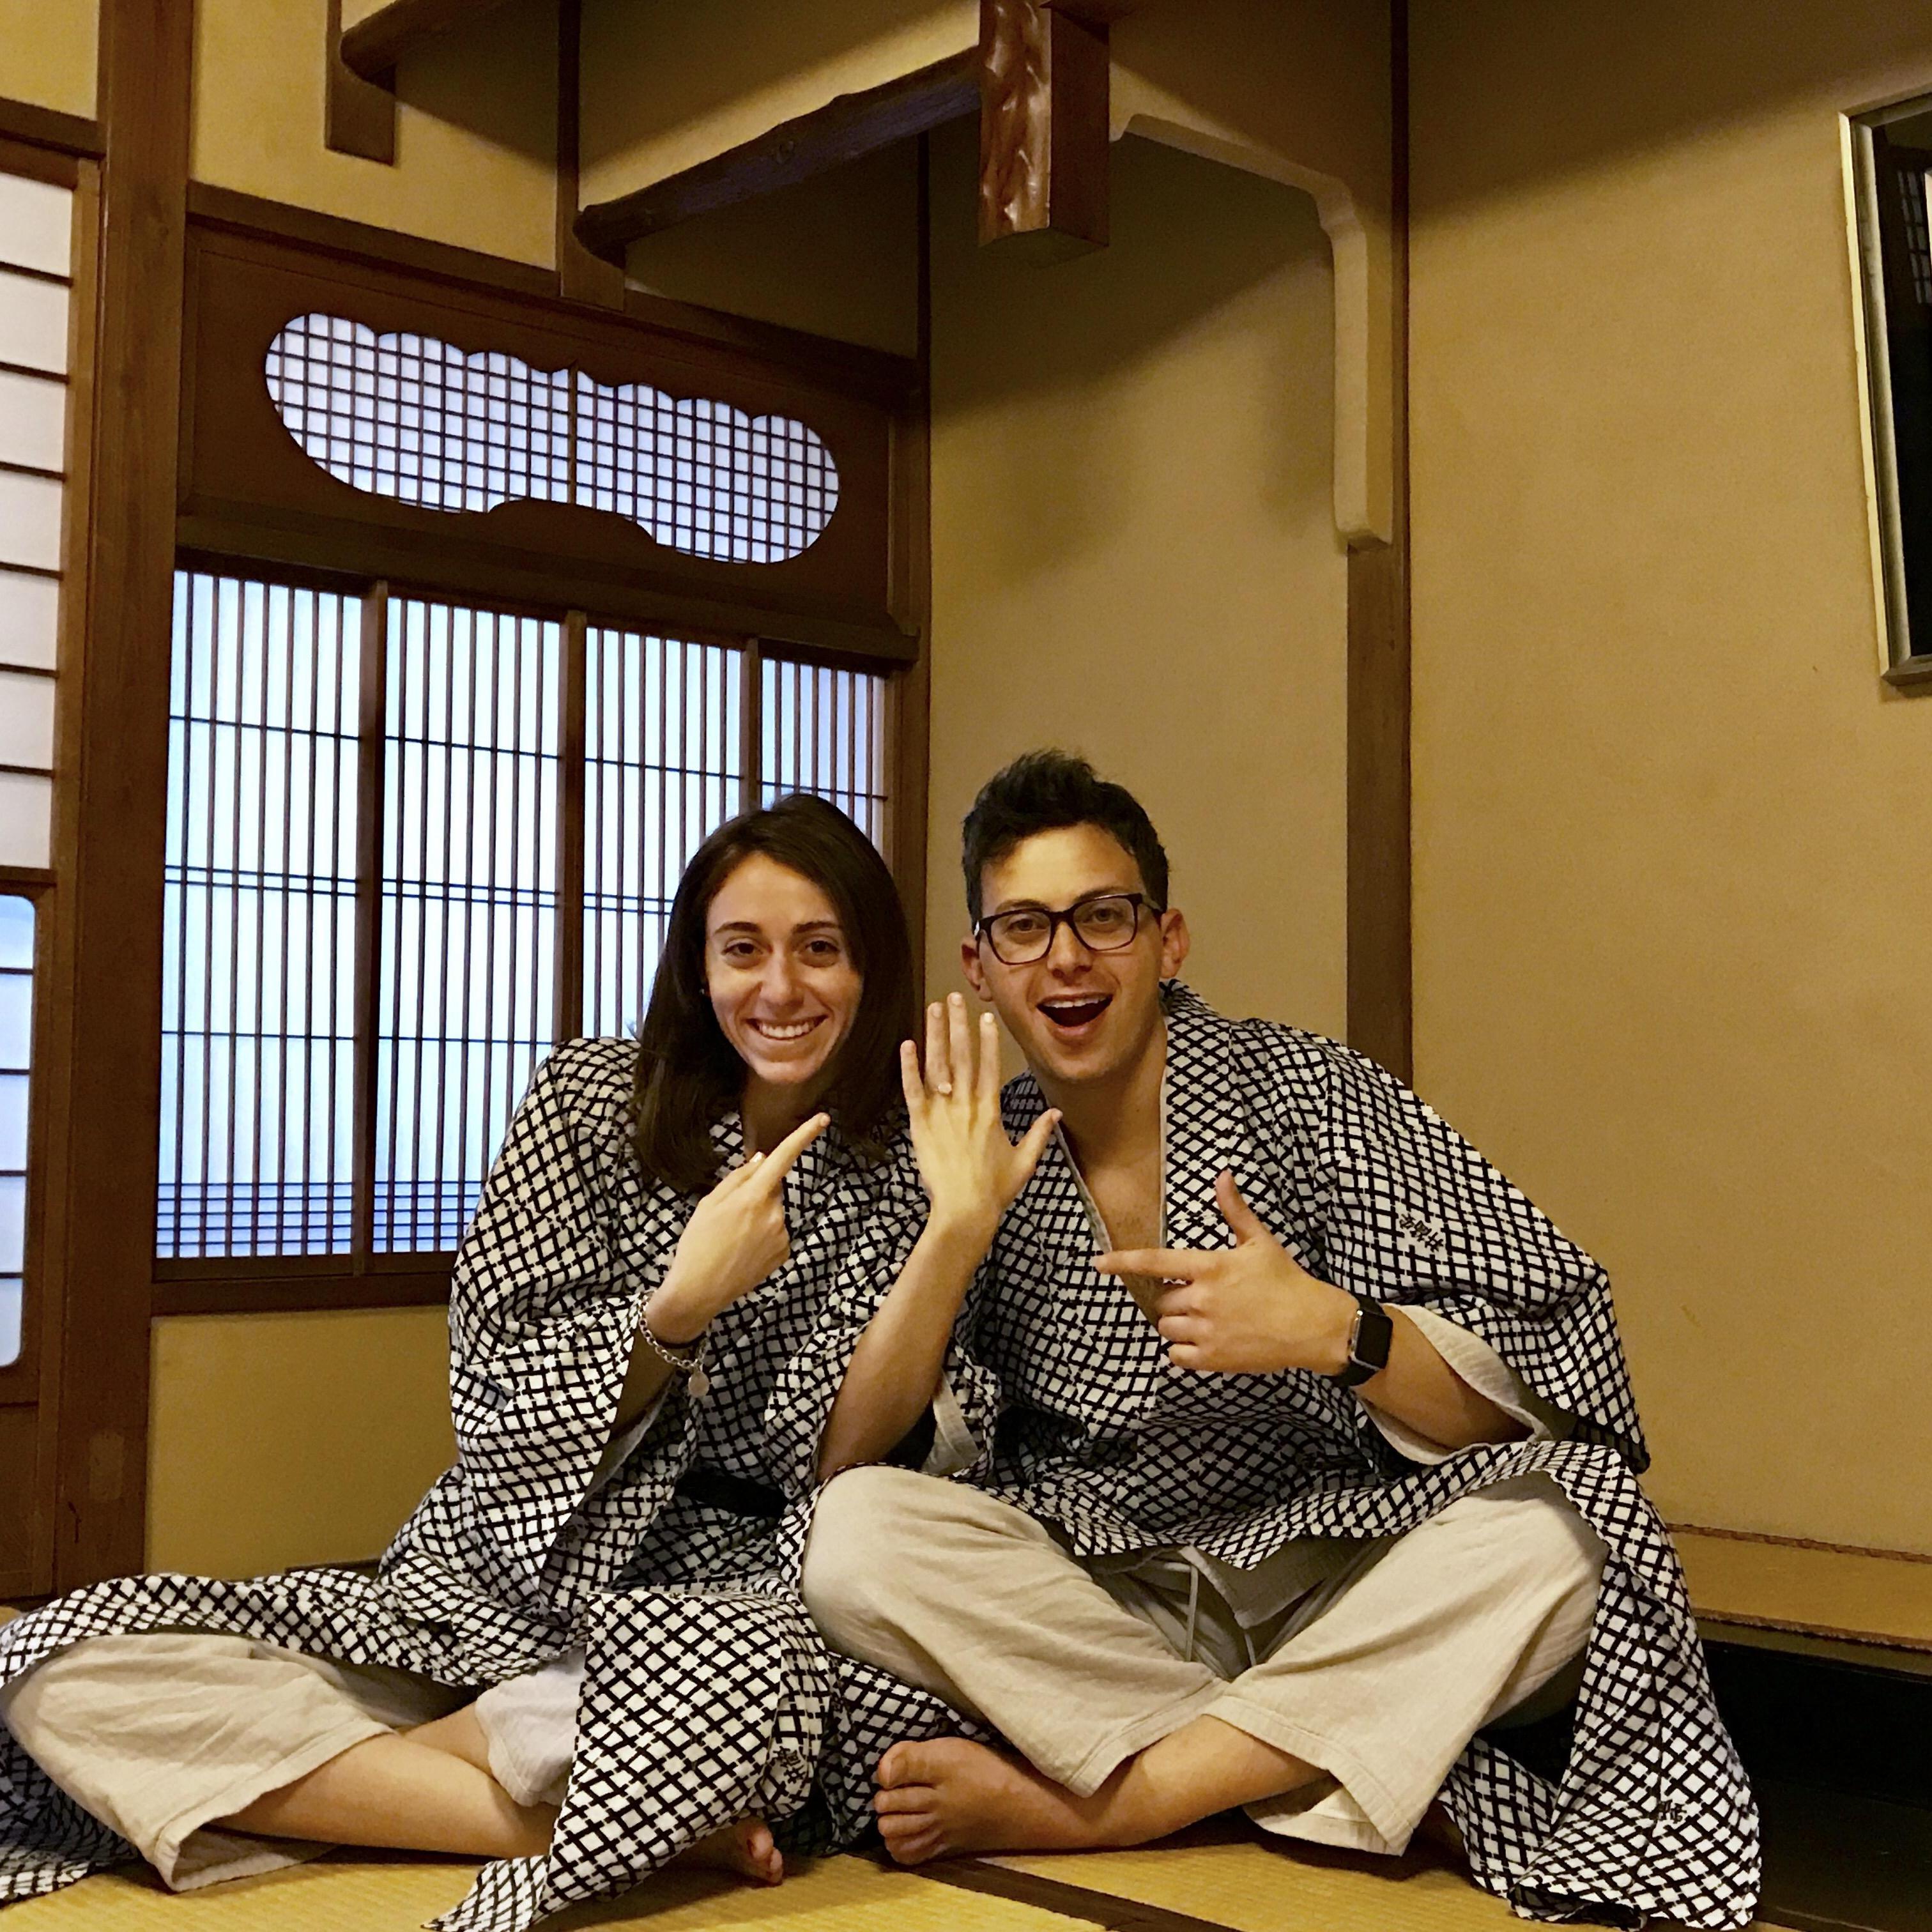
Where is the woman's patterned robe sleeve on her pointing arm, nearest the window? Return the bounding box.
[450,1041,682,1571]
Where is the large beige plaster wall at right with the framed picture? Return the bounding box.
[1413,0,1932,1551]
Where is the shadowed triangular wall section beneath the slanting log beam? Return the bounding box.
[628,141,919,355]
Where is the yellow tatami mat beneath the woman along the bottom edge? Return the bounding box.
[6,1857,1068,1932]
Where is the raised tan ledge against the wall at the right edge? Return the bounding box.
[1675,1530,1932,1650]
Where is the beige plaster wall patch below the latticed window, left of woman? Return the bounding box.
[147,1308,456,1577]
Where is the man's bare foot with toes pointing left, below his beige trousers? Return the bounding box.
[871,1737,1096,1864]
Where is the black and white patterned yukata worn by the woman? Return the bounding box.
[0,1039,960,1932]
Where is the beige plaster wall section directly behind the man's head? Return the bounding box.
[928,126,1347,1032]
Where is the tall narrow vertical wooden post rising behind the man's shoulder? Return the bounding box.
[1349,0,1414,1080]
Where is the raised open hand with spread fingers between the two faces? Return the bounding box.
[898,993,1061,1246]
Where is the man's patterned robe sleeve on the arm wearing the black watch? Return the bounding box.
[1275,1036,1648,1470]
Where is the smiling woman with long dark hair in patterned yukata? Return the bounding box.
[0,794,981,1932]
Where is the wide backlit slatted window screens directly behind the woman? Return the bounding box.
[158,572,889,1262]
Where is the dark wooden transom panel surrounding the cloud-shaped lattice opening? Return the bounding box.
[178,220,923,664]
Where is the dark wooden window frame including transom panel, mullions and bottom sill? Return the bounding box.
[153,185,930,1315]
